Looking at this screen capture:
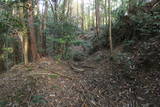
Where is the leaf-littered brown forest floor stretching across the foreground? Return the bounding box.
[0,50,160,107]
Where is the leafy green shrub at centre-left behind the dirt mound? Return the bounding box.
[46,21,80,59]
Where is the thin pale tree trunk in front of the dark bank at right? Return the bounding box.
[108,0,113,56]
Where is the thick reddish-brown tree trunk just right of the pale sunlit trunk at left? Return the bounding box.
[28,0,38,61]
